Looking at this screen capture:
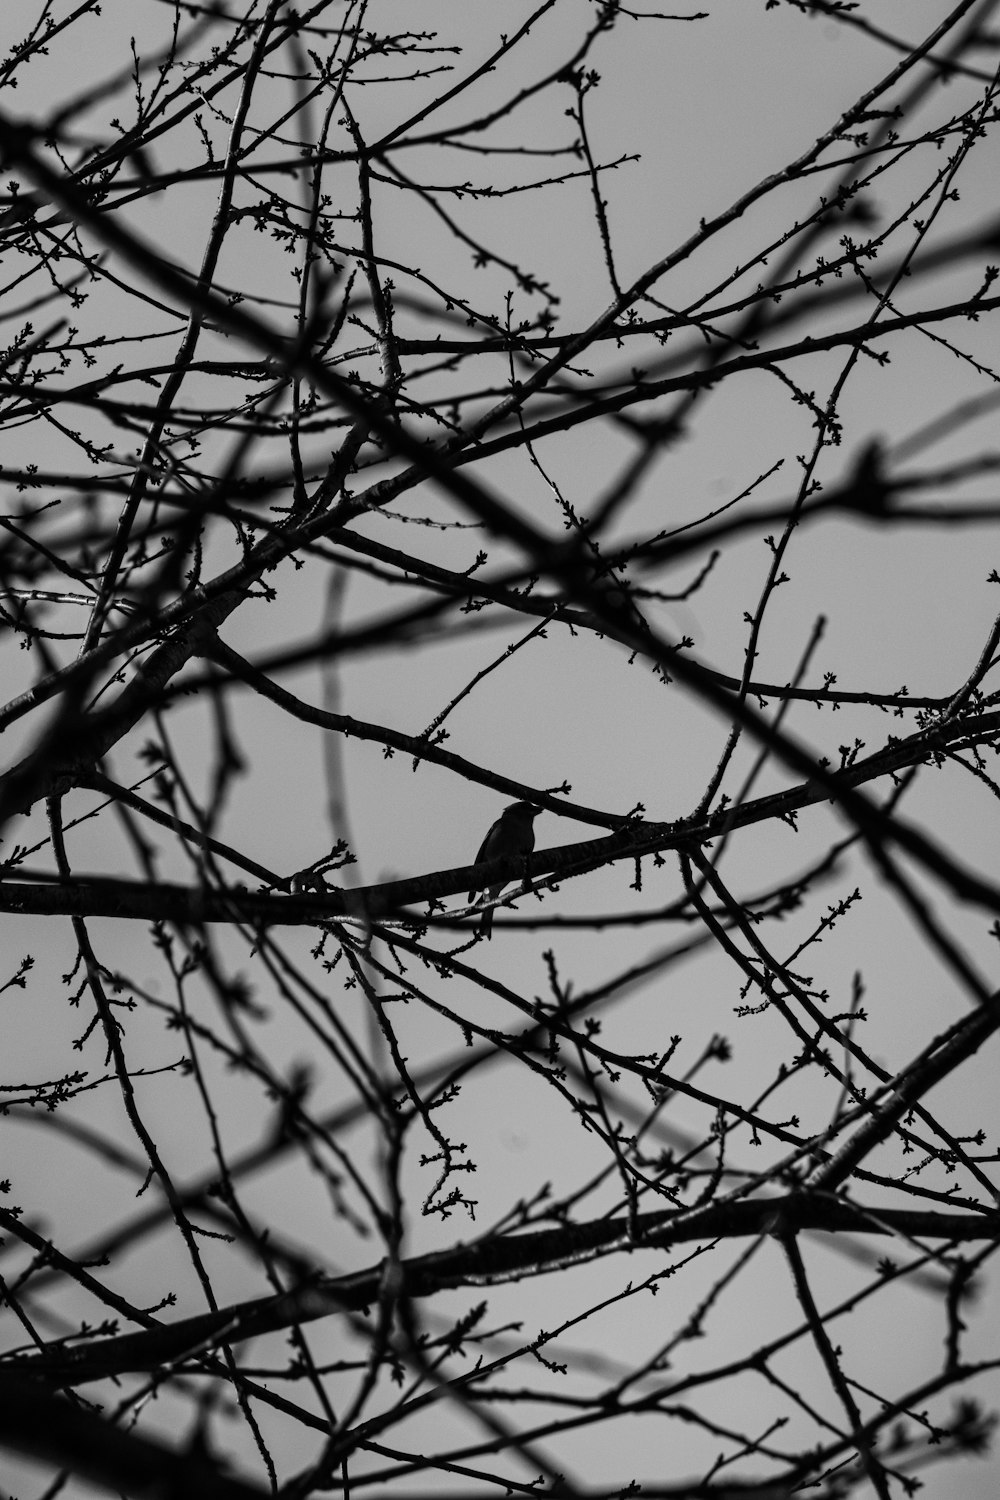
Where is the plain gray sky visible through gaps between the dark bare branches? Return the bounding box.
[0,0,1000,1500]
